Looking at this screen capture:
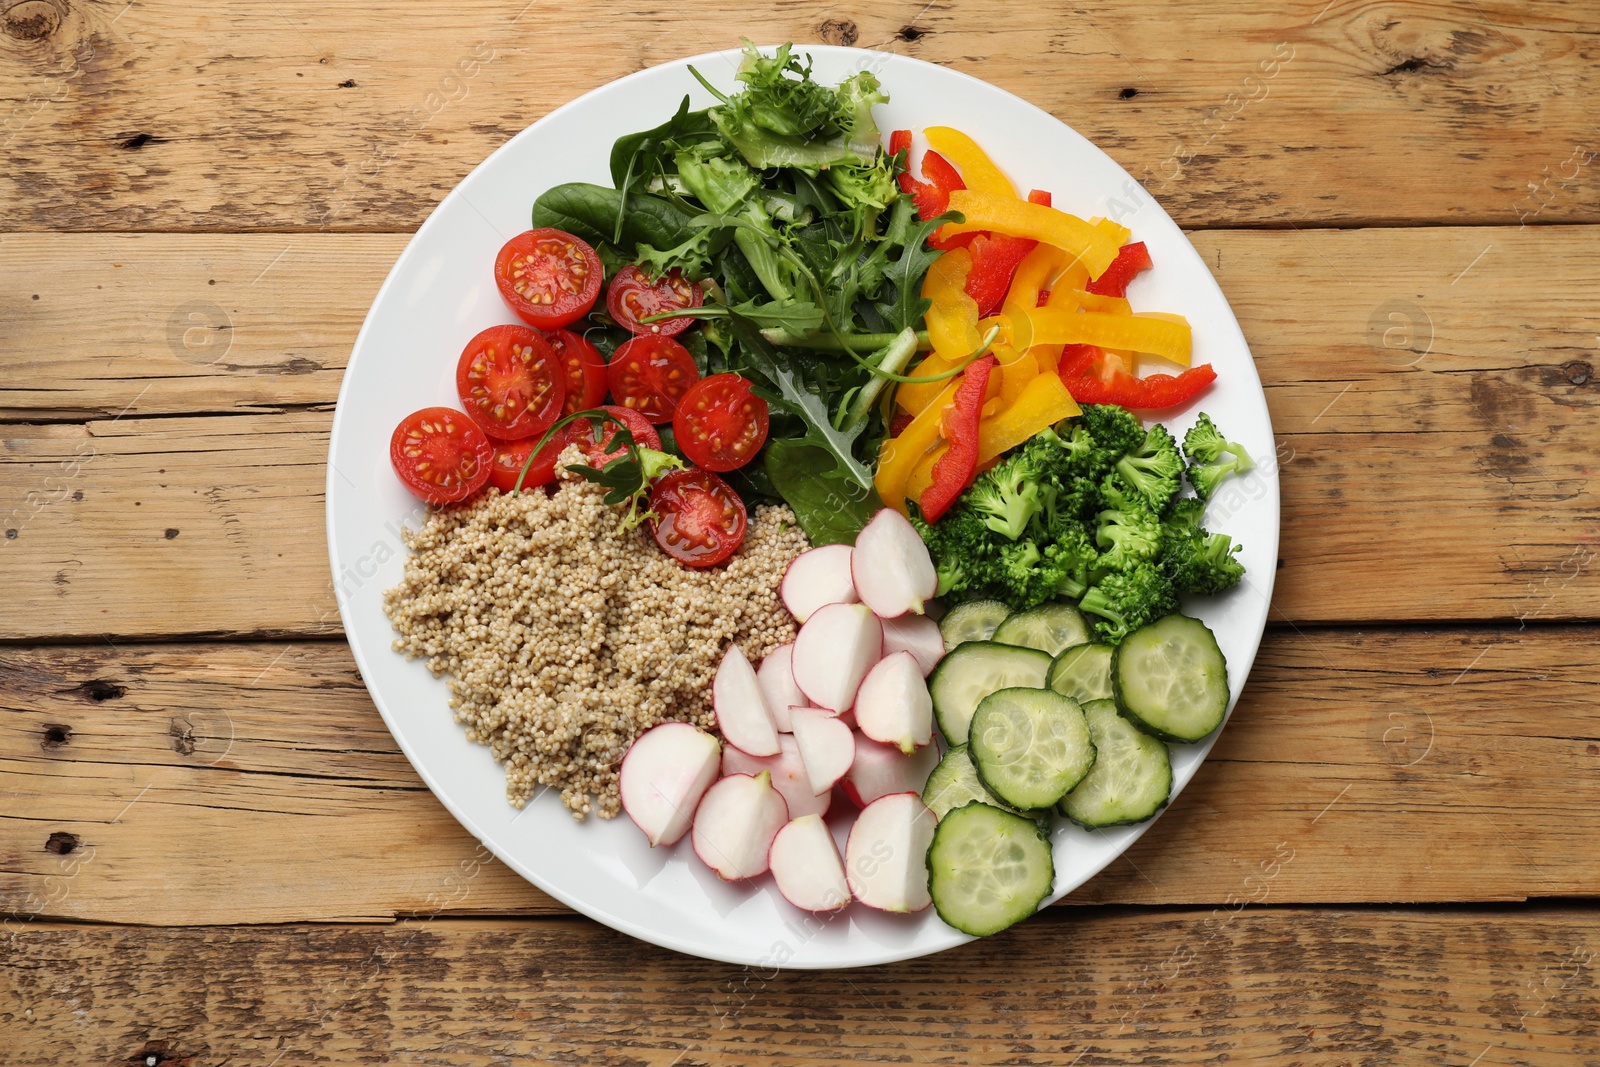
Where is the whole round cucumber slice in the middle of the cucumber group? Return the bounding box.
[968,689,1094,808]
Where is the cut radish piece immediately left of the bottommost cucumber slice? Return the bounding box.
[844,793,939,912]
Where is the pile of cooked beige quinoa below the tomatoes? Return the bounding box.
[384,458,808,819]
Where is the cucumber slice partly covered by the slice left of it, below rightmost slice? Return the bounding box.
[1059,701,1173,830]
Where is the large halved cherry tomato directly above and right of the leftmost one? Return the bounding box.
[456,326,566,442]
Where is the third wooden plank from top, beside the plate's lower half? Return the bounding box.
[0,627,1600,923]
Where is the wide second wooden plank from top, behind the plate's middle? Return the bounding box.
[0,227,1600,627]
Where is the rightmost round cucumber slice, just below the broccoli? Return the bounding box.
[1110,614,1227,741]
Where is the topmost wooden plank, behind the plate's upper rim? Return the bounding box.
[0,0,1600,230]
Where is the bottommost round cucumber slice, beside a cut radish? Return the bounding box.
[928,801,1056,937]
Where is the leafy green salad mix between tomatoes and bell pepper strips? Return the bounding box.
[533,42,960,544]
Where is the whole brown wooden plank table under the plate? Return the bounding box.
[0,0,1600,1067]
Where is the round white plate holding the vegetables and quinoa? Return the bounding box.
[328,48,1278,969]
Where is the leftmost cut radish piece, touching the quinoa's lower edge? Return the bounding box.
[618,723,723,848]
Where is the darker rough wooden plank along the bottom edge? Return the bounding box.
[0,909,1600,1067]
